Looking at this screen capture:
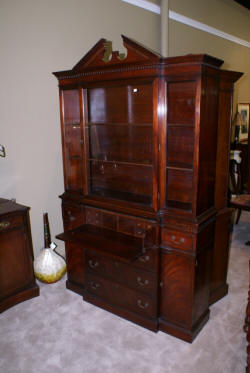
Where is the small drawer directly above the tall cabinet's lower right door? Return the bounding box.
[161,228,194,251]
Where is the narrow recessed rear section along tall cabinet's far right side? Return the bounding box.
[210,71,242,304]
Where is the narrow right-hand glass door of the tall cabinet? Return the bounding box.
[165,80,198,213]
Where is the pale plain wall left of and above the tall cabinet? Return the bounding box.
[0,0,160,255]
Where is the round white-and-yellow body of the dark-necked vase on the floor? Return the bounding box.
[34,242,66,284]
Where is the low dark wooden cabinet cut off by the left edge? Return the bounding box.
[0,198,39,312]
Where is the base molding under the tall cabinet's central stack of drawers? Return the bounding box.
[83,292,159,332]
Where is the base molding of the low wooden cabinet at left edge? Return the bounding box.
[0,284,40,313]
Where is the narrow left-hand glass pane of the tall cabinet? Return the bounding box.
[60,88,83,191]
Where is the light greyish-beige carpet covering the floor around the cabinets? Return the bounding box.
[0,213,250,373]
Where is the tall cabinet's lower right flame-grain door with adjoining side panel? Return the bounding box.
[160,246,211,330]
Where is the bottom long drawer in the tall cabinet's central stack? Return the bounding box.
[86,273,157,317]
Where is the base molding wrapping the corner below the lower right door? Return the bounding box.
[159,310,210,343]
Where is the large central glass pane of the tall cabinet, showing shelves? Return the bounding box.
[84,80,157,207]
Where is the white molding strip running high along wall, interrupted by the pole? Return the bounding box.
[122,0,250,48]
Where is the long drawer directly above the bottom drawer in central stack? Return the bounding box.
[86,252,157,295]
